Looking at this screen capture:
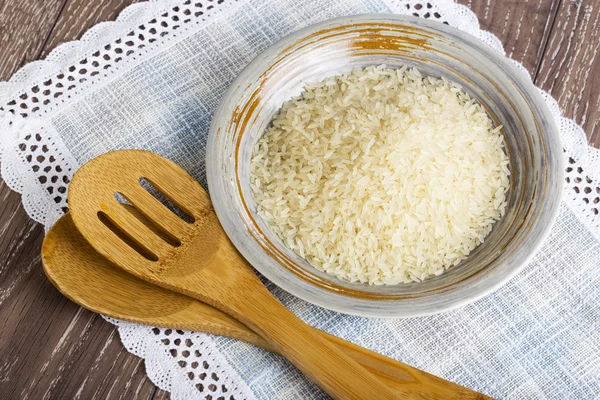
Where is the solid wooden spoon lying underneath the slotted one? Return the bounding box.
[42,209,487,400]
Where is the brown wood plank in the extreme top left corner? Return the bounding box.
[0,0,65,81]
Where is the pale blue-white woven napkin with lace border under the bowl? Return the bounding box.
[0,0,600,399]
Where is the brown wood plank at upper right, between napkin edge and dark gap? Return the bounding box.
[458,0,560,76]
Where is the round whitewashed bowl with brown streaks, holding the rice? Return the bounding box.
[207,14,563,317]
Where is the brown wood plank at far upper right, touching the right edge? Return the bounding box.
[535,0,600,148]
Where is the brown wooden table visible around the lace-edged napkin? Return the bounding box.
[0,0,600,399]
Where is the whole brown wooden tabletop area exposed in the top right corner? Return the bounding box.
[459,0,600,148]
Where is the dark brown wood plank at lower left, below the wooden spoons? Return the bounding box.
[0,217,155,399]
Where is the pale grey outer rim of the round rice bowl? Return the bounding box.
[206,14,564,318]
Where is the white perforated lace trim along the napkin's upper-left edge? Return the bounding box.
[0,0,246,117]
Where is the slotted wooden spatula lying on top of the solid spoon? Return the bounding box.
[69,150,400,399]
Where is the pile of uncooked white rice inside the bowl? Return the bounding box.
[251,66,509,284]
